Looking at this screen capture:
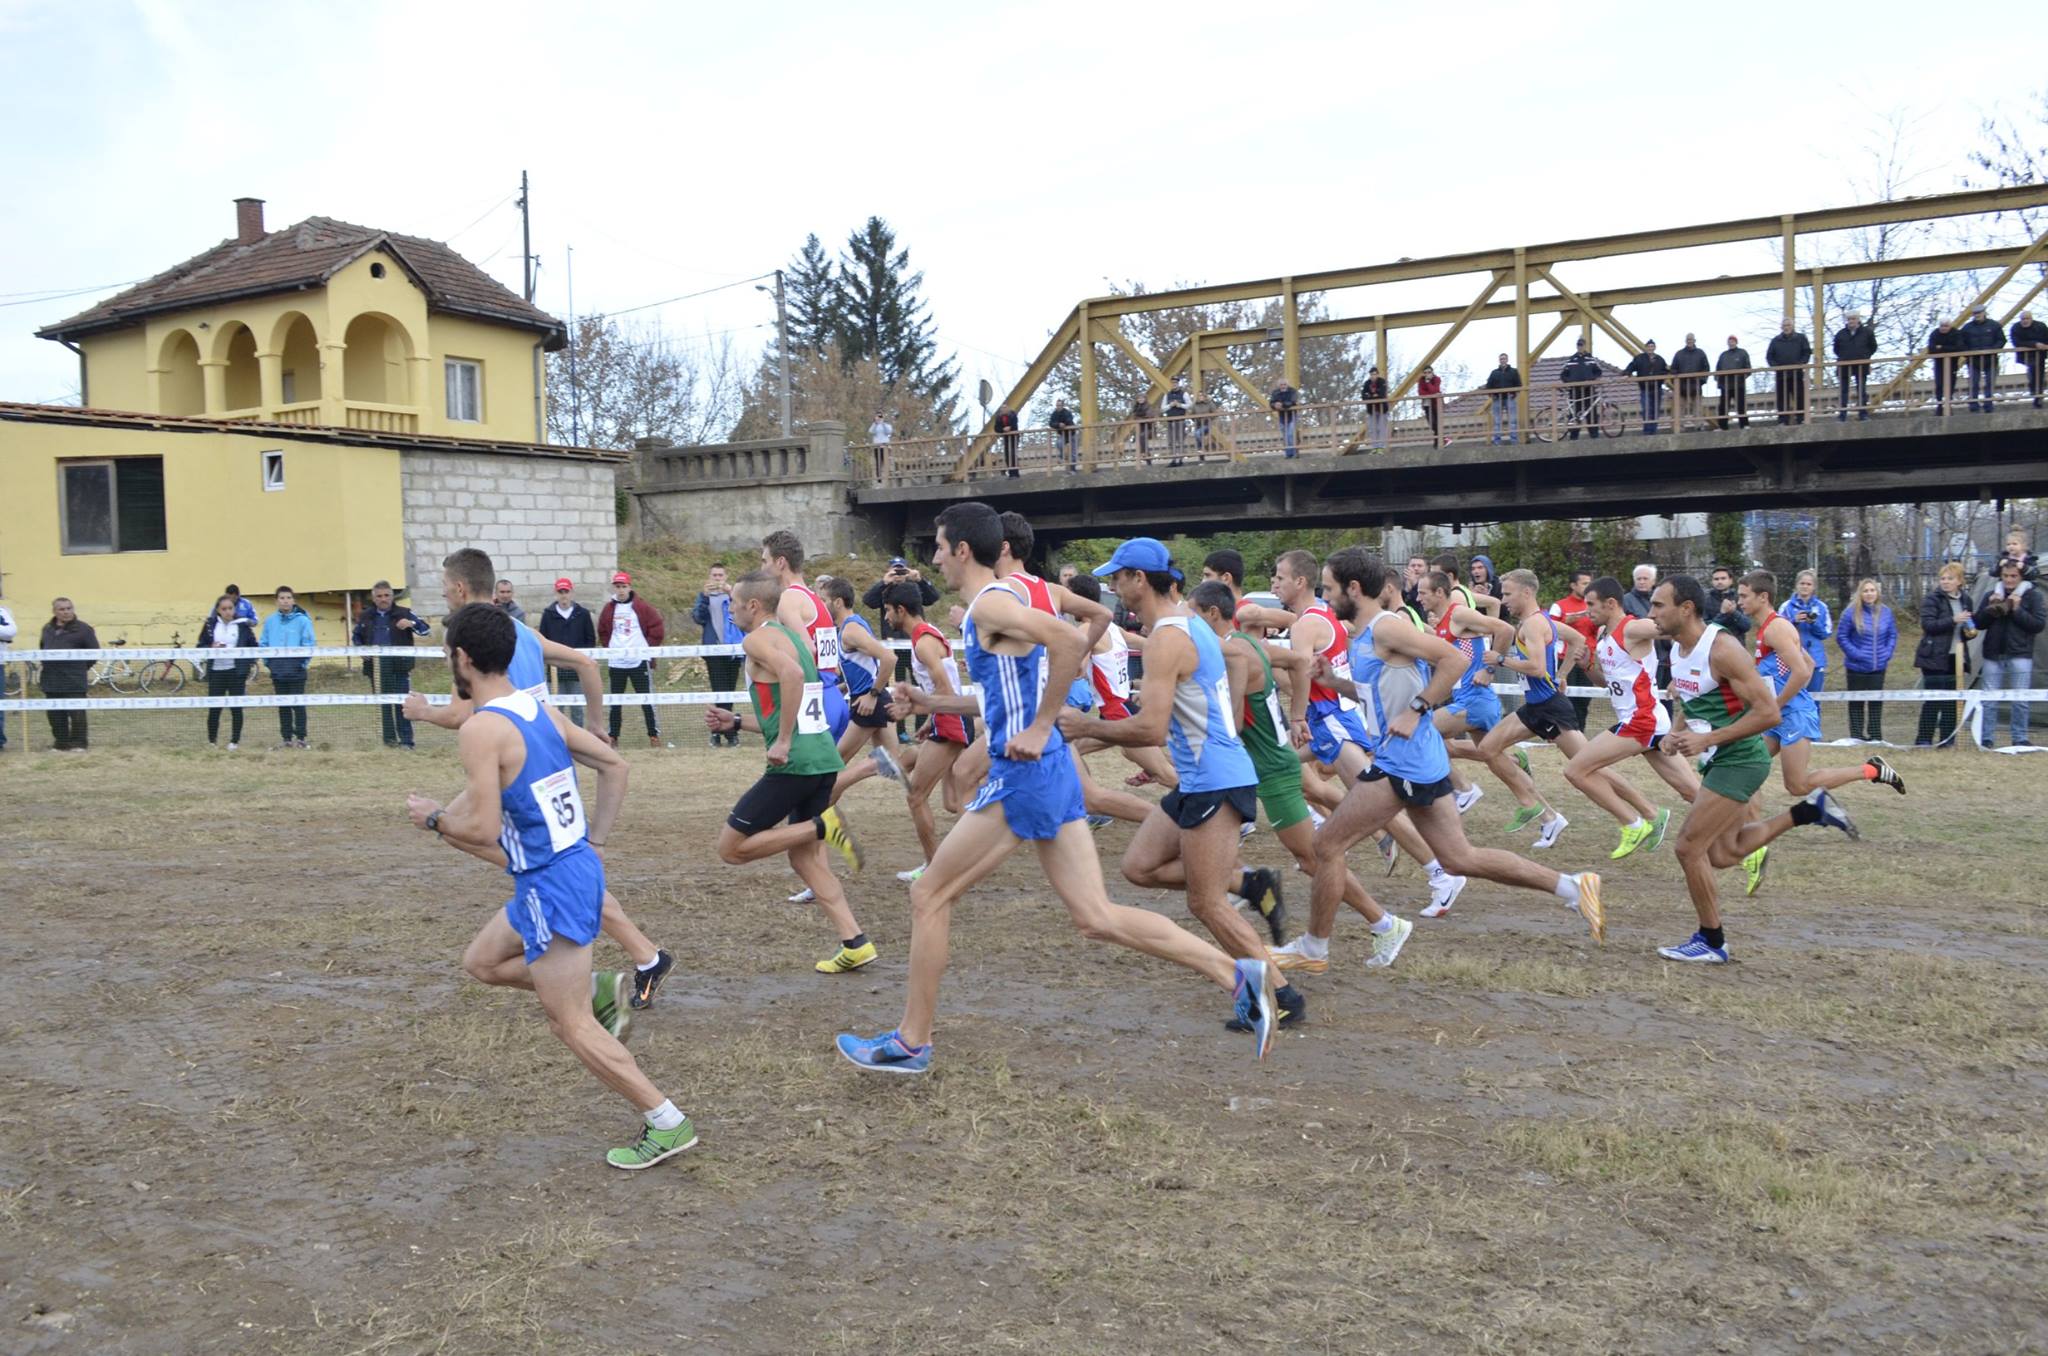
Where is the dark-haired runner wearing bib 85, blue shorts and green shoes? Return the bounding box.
[406,602,696,1172]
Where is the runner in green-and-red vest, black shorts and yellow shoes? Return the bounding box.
[705,569,874,975]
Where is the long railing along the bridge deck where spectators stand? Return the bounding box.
[852,348,2048,485]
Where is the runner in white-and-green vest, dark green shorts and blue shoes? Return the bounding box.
[1651,574,1853,965]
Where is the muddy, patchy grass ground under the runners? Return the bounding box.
[0,739,2048,1352]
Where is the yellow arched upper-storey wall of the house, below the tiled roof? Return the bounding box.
[78,250,541,442]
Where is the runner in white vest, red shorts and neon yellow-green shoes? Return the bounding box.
[1565,576,1700,860]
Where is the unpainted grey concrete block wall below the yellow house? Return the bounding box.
[399,451,618,615]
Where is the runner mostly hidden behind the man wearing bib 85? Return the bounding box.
[406,547,676,1007]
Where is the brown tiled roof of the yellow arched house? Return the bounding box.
[37,217,565,348]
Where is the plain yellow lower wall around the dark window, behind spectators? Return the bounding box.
[0,420,406,645]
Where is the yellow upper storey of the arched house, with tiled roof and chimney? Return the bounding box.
[37,199,567,442]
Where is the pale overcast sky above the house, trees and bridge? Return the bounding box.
[0,0,2044,417]
